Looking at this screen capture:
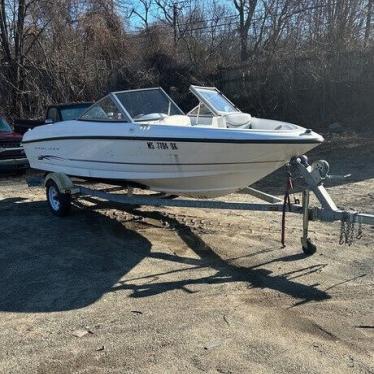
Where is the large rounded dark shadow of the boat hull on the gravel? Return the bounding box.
[0,198,151,312]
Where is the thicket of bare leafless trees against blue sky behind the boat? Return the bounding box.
[0,0,374,124]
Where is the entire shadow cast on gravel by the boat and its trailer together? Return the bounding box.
[0,199,329,312]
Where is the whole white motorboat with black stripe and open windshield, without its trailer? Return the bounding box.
[23,86,323,198]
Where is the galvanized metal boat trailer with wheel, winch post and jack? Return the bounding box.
[27,156,374,255]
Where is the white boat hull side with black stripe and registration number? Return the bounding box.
[24,121,320,198]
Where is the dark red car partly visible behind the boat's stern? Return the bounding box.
[0,117,29,171]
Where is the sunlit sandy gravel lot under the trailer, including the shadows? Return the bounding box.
[0,133,374,373]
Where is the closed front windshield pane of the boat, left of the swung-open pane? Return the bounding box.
[115,88,184,121]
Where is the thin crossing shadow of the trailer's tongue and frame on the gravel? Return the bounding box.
[113,210,330,305]
